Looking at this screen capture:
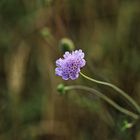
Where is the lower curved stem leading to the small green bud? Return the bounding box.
[65,85,139,119]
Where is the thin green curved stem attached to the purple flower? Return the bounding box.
[80,72,140,113]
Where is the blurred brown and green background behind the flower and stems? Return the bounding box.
[0,0,140,140]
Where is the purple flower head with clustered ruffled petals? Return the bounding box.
[55,50,86,80]
